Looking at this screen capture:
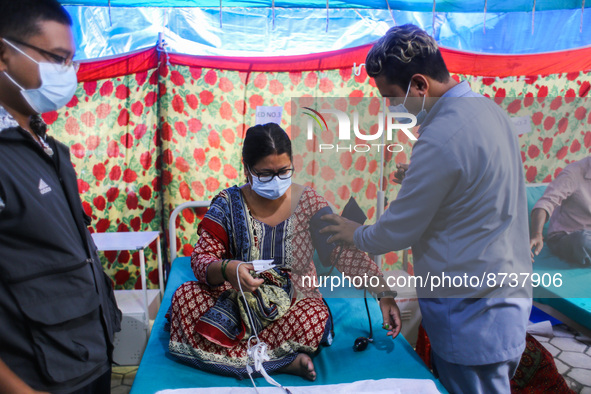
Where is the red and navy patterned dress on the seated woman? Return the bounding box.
[168,186,381,378]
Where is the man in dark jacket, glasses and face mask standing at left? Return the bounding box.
[0,0,120,394]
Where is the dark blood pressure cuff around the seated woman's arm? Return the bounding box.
[310,197,367,267]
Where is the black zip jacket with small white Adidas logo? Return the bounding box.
[0,127,121,393]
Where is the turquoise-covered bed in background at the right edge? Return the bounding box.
[527,183,591,336]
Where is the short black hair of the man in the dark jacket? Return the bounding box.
[0,0,72,39]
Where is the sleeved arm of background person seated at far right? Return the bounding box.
[529,167,577,262]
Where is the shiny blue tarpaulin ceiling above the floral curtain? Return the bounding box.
[61,0,591,60]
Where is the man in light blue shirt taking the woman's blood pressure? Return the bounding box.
[325,25,531,394]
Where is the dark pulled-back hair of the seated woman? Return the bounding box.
[242,123,292,168]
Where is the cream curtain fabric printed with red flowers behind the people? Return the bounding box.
[43,62,591,288]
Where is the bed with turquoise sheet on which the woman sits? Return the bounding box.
[131,201,446,394]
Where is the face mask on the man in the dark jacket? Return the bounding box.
[4,39,78,114]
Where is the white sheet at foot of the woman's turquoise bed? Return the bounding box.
[156,379,439,394]
